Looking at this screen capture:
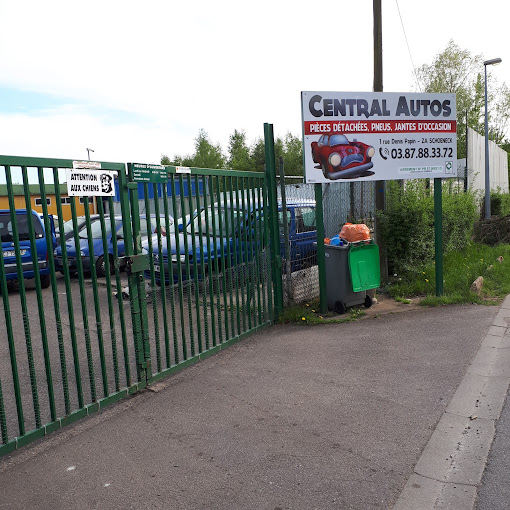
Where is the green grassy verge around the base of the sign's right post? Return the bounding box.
[384,243,510,306]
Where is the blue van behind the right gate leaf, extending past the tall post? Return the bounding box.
[143,200,317,284]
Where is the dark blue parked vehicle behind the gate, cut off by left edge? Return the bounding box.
[0,209,56,289]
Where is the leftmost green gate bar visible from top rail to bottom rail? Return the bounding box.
[5,165,41,428]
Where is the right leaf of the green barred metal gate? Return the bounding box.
[122,164,272,383]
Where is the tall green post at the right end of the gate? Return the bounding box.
[264,123,283,320]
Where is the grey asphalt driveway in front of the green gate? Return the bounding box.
[0,305,504,510]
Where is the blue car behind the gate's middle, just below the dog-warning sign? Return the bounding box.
[55,214,174,276]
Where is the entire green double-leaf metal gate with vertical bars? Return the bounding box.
[0,156,273,456]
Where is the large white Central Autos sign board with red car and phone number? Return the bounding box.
[301,92,457,183]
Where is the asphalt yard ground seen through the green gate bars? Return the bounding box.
[0,267,268,439]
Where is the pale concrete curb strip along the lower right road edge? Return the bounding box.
[393,295,510,510]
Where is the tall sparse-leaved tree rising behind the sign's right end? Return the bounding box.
[416,40,510,158]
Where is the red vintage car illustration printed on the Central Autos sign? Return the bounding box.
[312,135,375,180]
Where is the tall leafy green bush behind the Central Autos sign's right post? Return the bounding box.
[379,180,478,274]
